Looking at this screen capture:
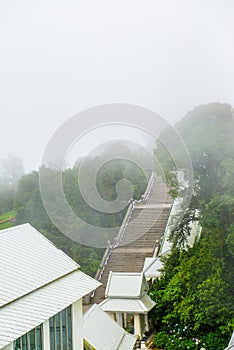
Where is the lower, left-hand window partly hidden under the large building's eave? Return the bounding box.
[13,325,43,350]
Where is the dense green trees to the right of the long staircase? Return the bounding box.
[150,103,234,350]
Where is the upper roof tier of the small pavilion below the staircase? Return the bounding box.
[105,271,148,298]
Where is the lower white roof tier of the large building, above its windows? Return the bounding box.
[0,270,100,349]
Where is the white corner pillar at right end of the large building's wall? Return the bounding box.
[72,298,84,350]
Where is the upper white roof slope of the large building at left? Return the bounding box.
[0,224,79,307]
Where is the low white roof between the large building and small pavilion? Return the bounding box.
[83,304,136,350]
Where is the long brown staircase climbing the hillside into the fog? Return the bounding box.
[90,174,172,304]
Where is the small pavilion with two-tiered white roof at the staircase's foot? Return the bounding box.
[99,271,155,338]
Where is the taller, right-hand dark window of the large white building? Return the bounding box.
[50,306,72,350]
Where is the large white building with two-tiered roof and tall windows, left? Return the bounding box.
[0,224,100,350]
